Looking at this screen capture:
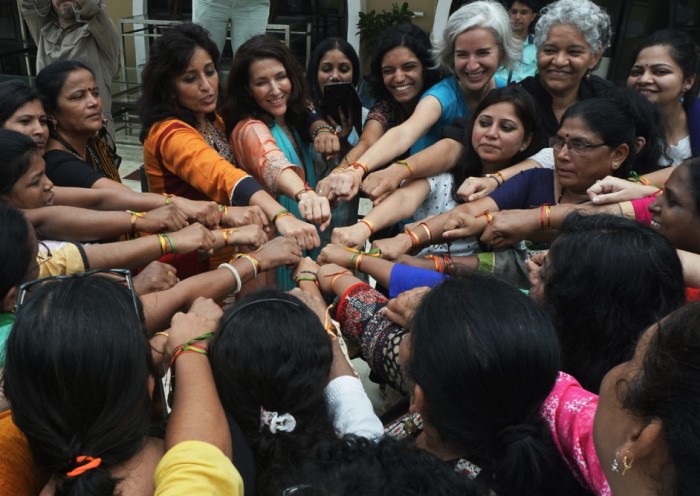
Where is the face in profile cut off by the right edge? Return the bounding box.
[649,165,700,253]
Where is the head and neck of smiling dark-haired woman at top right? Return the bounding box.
[627,29,700,166]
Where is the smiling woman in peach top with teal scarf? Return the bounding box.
[222,35,330,287]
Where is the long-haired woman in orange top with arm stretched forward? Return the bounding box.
[140,23,320,256]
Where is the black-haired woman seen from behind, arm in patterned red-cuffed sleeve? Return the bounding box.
[308,264,582,494]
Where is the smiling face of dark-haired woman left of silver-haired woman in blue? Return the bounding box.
[382,47,424,104]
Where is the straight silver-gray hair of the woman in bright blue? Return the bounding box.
[432,0,522,74]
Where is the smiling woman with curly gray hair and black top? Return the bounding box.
[520,0,613,136]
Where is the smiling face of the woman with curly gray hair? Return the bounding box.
[537,24,600,95]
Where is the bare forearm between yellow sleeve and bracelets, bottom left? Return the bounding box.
[165,353,232,458]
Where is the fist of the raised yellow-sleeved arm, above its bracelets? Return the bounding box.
[165,297,223,356]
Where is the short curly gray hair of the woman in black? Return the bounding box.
[535,0,612,55]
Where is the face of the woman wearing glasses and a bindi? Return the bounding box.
[554,117,629,193]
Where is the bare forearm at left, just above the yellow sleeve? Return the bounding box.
[24,206,131,241]
